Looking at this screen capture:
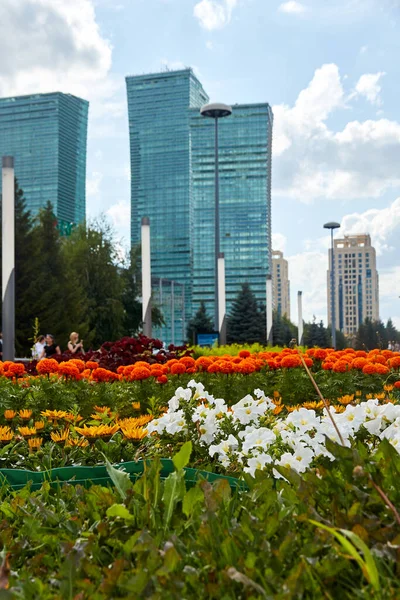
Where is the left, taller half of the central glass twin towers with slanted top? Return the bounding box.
[126,69,208,343]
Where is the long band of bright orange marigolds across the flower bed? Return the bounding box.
[0,348,400,388]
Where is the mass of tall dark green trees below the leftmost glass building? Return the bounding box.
[0,182,162,356]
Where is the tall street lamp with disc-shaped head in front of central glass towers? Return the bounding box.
[200,103,232,343]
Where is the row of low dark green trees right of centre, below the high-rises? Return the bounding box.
[187,283,400,350]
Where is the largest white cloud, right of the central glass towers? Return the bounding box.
[273,64,400,203]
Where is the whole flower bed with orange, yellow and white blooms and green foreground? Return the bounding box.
[0,349,400,600]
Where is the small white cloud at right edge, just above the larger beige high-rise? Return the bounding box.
[338,198,400,253]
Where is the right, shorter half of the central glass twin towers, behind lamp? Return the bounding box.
[190,104,273,315]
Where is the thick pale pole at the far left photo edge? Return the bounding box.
[2,156,15,360]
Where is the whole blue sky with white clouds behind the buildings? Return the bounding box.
[0,0,400,327]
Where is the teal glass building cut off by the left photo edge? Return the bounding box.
[0,92,89,224]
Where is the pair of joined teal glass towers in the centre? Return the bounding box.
[126,69,272,343]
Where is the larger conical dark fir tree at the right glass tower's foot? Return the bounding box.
[227,283,265,344]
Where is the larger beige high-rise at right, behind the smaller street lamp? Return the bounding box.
[327,234,379,335]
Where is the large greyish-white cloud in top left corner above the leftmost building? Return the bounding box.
[0,0,112,97]
